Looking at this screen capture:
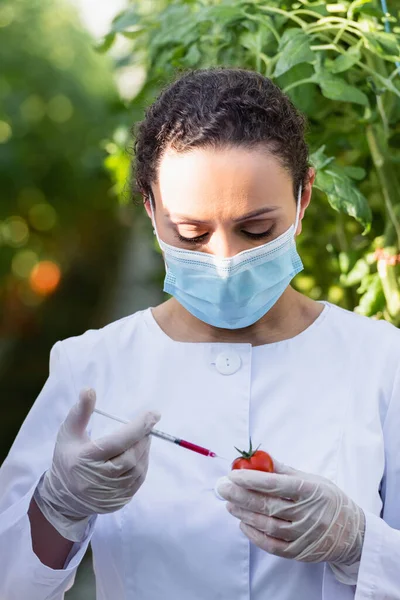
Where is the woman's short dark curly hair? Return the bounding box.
[132,67,310,204]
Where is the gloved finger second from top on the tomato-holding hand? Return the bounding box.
[217,482,295,521]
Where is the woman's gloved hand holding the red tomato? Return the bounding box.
[218,459,365,565]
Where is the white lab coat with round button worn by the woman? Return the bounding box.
[0,303,400,600]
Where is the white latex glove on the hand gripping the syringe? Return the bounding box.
[33,390,160,542]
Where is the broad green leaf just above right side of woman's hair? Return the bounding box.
[273,27,315,77]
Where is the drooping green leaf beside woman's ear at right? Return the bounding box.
[314,167,372,234]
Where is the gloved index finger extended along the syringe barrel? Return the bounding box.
[86,411,161,460]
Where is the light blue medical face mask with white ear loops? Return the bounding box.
[151,186,303,329]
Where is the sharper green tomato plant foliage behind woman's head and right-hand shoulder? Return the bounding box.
[99,0,400,324]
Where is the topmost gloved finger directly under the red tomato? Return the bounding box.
[228,469,315,500]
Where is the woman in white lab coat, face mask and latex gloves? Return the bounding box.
[0,69,400,600]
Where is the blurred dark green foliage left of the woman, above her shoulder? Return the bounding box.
[0,0,125,462]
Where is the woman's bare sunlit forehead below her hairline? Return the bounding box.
[155,147,293,218]
